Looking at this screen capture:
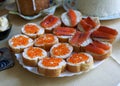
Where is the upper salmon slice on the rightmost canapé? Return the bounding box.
[98,26,118,36]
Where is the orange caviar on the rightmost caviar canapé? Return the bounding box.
[68,53,88,63]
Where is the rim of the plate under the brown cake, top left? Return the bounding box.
[6,2,60,20]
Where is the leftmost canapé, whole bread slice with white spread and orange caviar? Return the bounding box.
[8,34,34,53]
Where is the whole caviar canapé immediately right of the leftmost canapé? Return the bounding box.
[34,34,59,51]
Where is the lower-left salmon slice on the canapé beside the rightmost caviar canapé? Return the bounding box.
[85,43,105,54]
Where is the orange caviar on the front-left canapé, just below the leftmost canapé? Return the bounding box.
[27,47,43,58]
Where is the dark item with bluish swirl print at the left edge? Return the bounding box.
[0,47,14,71]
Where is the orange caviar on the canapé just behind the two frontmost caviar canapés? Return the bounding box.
[52,44,70,56]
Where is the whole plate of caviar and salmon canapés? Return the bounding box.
[8,9,118,77]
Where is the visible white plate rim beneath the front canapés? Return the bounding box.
[15,54,105,77]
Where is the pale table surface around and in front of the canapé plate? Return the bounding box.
[0,0,120,86]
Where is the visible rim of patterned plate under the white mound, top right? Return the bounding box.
[63,0,120,20]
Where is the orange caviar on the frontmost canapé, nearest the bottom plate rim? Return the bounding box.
[42,57,62,67]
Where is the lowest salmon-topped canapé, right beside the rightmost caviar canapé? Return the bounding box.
[85,41,112,60]
